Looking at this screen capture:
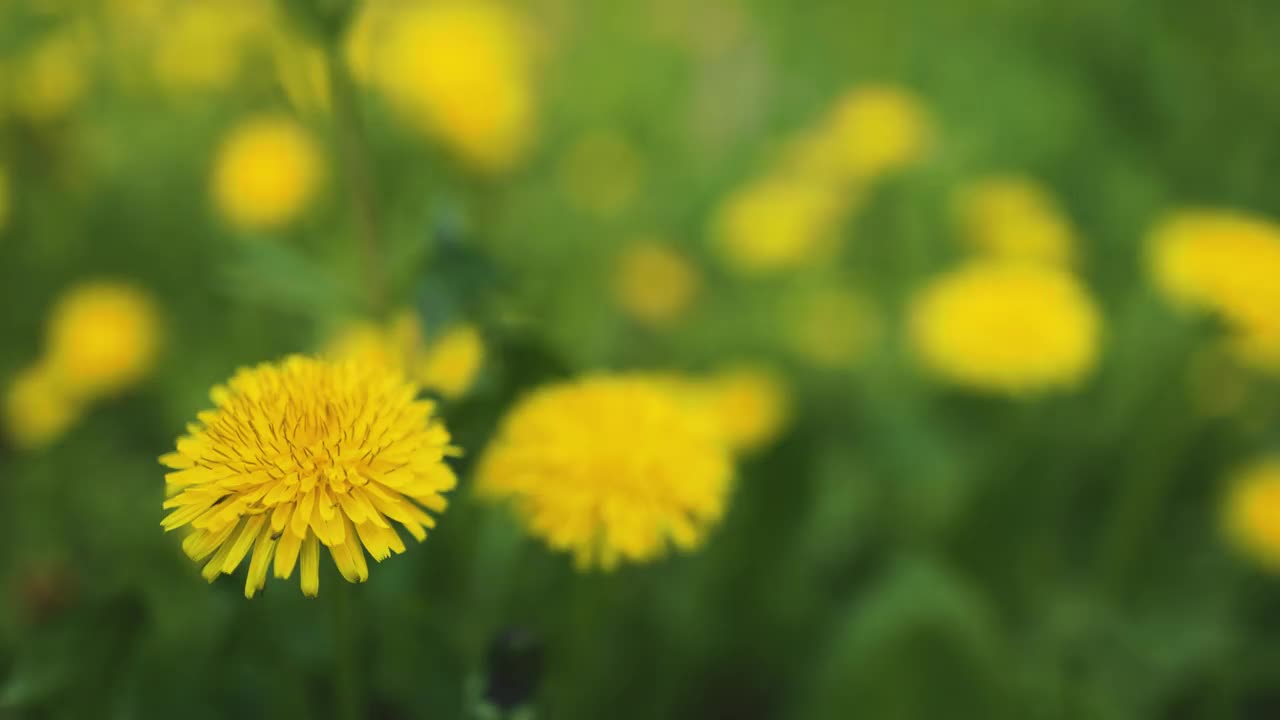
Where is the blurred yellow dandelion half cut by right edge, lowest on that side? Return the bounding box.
[1224,456,1280,570]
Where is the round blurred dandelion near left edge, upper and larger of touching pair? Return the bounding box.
[46,281,161,397]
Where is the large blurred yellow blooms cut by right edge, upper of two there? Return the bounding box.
[1149,210,1280,368]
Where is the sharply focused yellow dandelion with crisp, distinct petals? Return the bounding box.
[160,356,456,597]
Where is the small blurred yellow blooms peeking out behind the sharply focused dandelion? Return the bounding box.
[325,310,485,400]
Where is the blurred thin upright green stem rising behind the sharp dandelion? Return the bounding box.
[325,35,385,313]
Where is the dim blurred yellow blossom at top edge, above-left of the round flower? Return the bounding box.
[151,0,271,92]
